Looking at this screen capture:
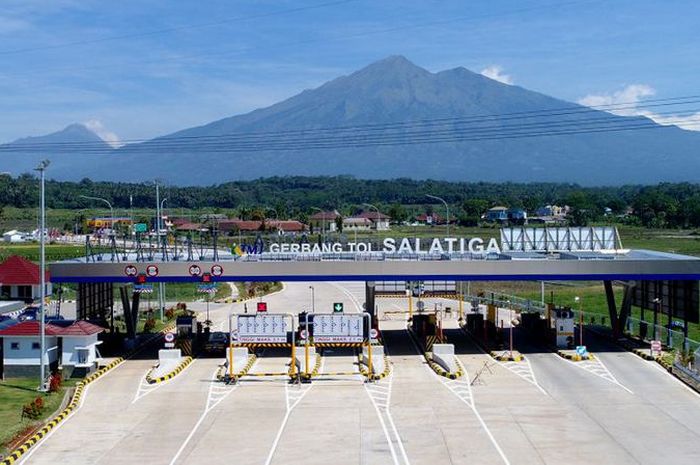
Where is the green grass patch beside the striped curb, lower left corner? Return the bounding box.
[0,378,78,454]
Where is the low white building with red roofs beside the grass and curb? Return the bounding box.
[0,320,104,378]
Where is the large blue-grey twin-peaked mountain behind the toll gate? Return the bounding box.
[1,56,700,185]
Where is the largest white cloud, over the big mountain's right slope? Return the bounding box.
[578,84,700,131]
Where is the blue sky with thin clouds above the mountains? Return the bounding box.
[0,0,700,141]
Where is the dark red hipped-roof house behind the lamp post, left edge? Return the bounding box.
[0,255,51,302]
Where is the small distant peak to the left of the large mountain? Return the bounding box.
[0,123,112,179]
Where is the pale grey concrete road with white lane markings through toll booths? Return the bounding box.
[17,283,700,465]
